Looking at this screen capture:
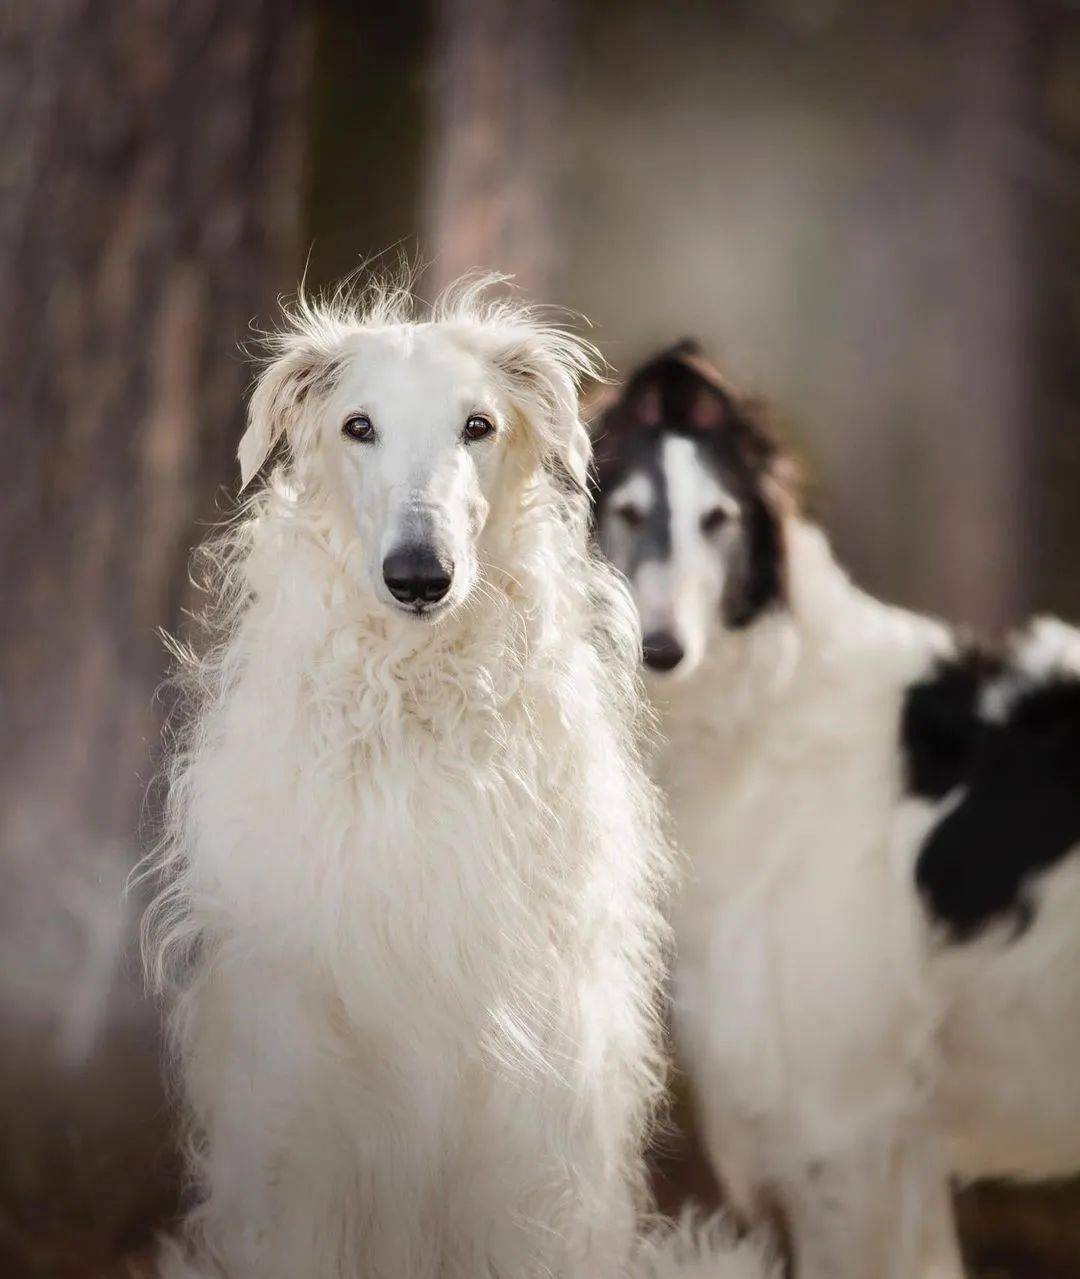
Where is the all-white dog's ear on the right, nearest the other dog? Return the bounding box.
[494,325,594,492]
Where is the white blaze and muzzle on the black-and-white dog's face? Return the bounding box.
[631,435,738,677]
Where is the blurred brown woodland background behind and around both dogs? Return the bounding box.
[0,0,1080,1279]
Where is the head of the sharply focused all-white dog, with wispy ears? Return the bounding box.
[241,280,591,620]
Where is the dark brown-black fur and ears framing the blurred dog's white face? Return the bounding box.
[595,338,787,628]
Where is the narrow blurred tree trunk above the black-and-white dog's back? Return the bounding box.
[924,0,1034,629]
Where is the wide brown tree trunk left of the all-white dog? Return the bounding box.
[0,0,308,1276]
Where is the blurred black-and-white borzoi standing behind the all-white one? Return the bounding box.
[598,345,1080,1279]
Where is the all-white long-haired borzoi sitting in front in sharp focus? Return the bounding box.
[147,288,778,1279]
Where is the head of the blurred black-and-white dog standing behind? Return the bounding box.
[595,341,787,677]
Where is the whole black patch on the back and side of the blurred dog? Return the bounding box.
[902,654,1080,941]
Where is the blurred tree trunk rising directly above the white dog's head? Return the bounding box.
[427,0,568,298]
